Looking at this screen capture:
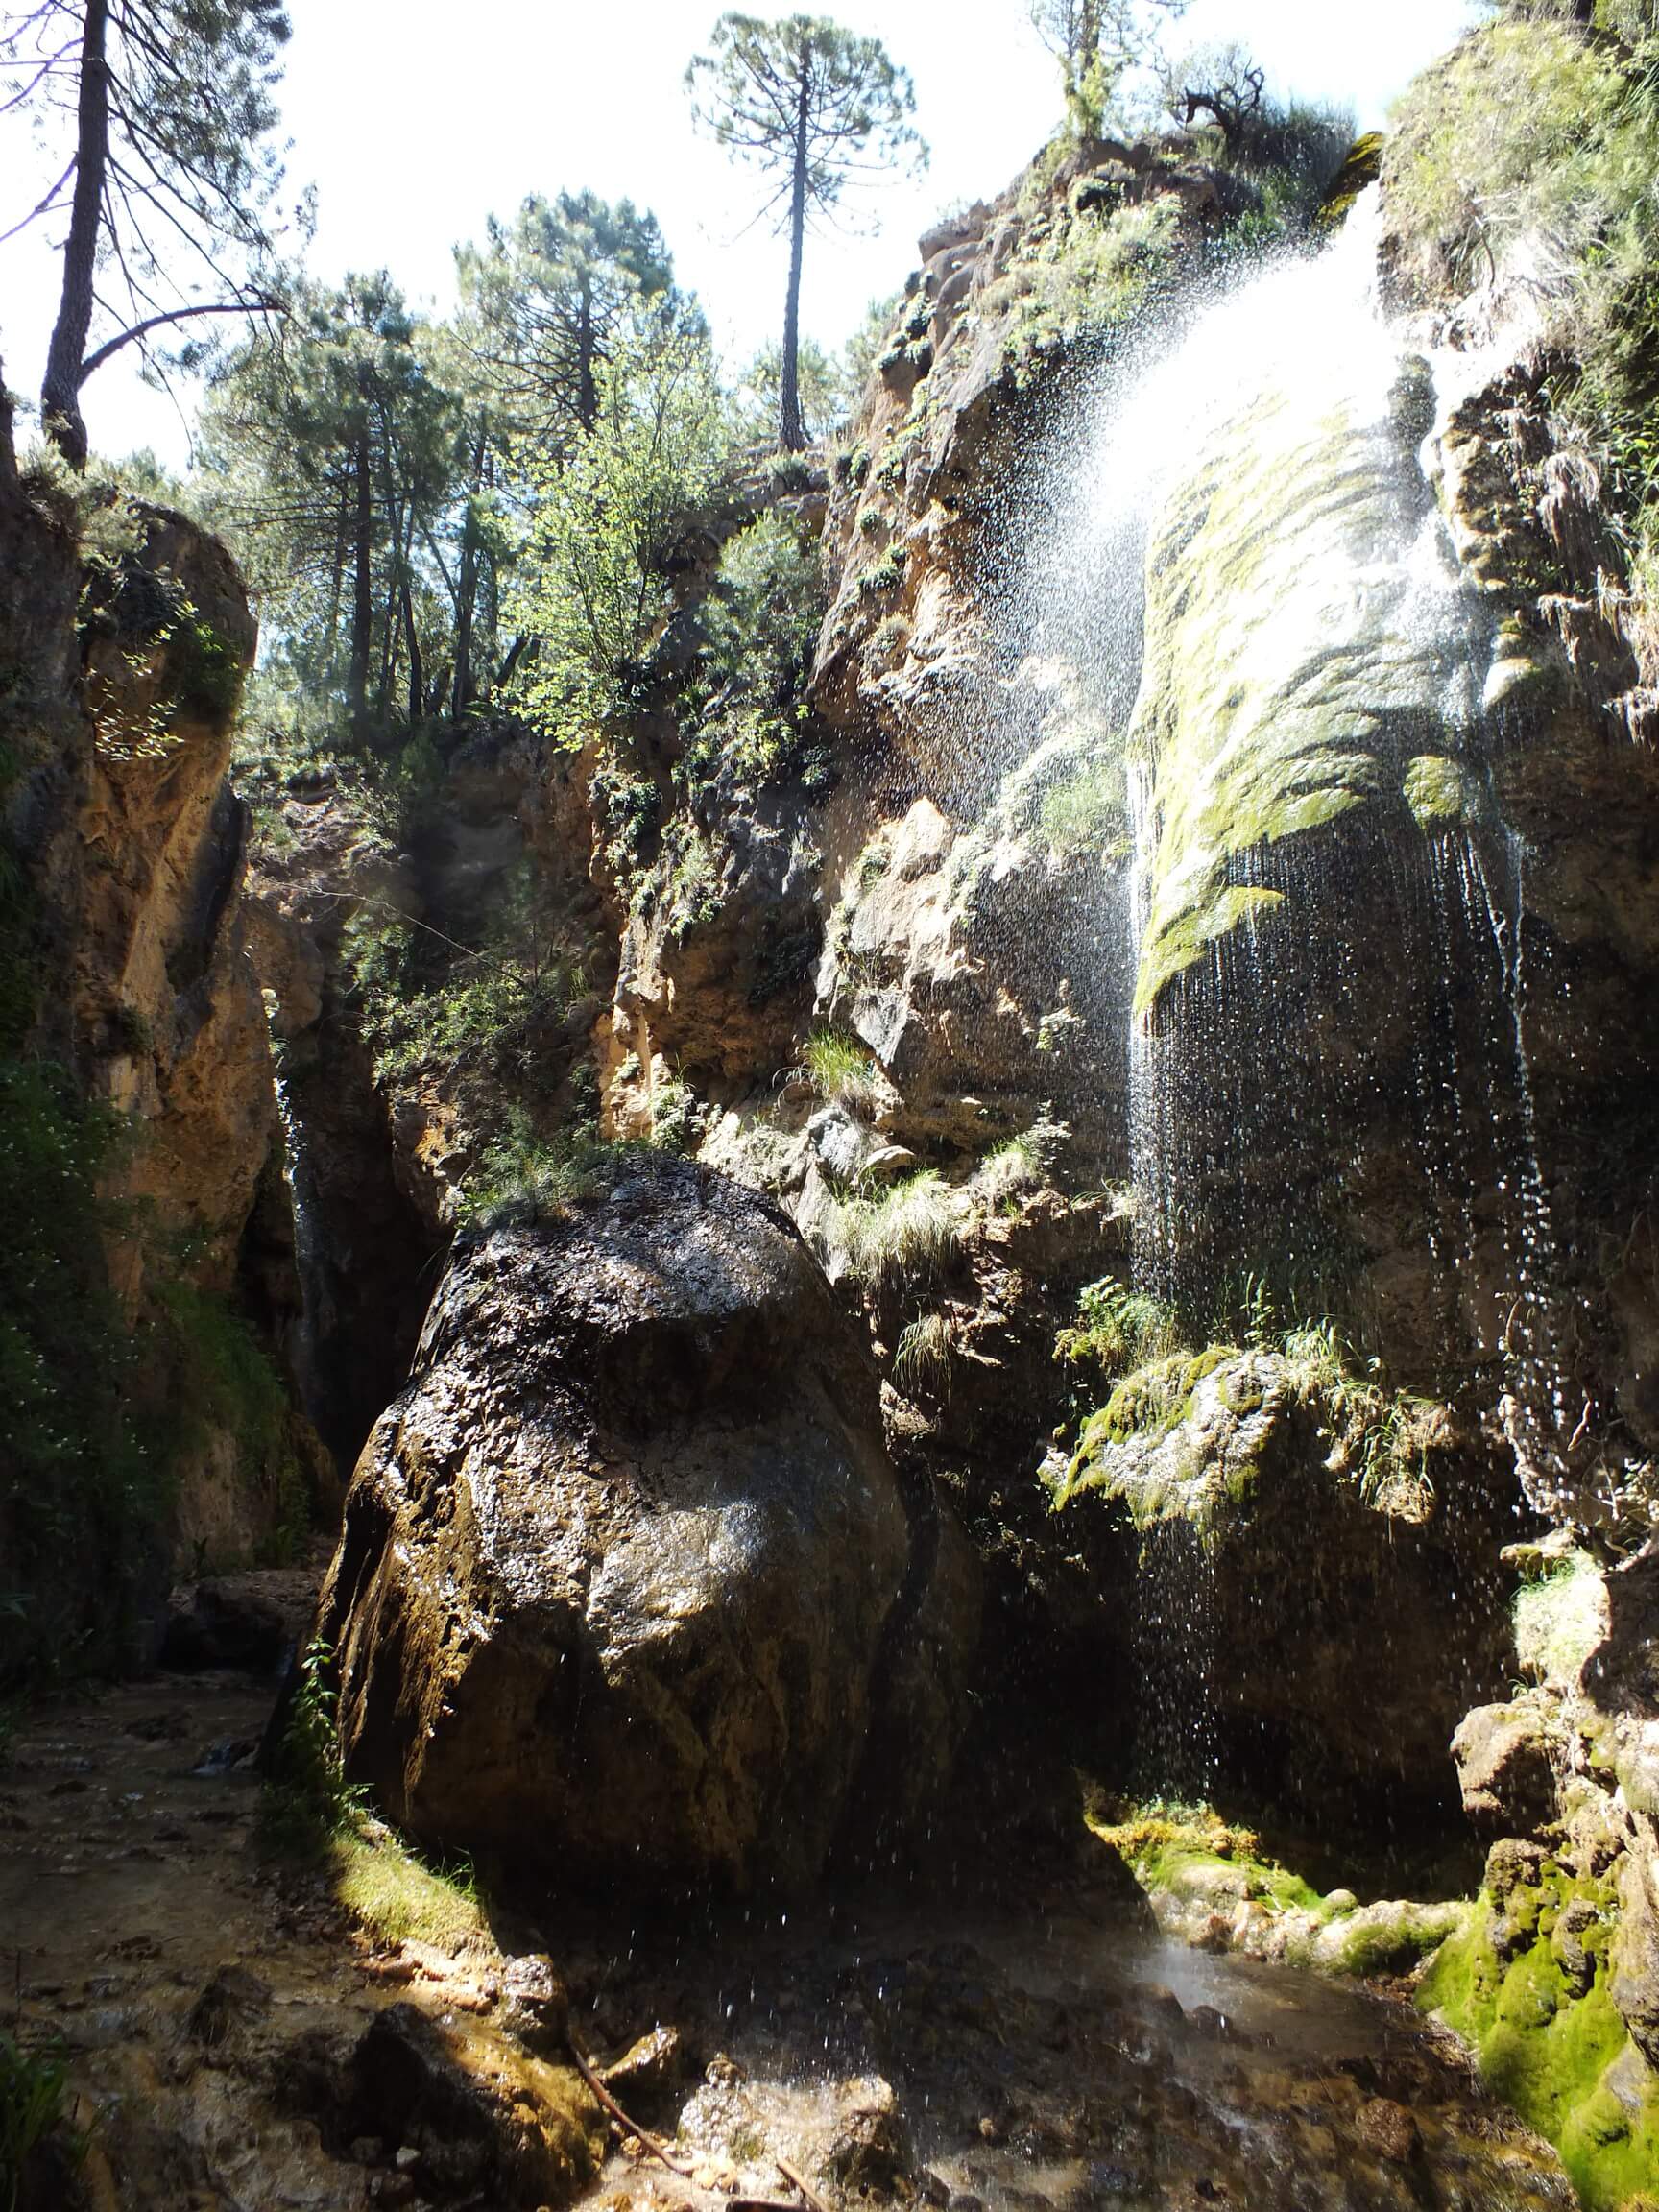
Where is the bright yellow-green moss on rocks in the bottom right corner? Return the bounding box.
[1418,1861,1659,2212]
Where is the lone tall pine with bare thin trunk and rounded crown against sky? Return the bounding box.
[685,13,926,451]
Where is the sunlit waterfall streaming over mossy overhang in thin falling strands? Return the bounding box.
[1031,195,1577,1791]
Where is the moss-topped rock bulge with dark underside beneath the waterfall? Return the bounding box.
[1069,1347,1508,1822]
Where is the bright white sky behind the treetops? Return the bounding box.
[0,0,1471,467]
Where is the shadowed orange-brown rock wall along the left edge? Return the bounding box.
[0,397,319,1674]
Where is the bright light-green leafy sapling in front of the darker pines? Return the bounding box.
[509,319,723,748]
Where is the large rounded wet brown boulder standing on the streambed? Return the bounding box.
[323,1155,974,1889]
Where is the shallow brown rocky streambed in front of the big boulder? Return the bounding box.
[0,1592,1575,2212]
